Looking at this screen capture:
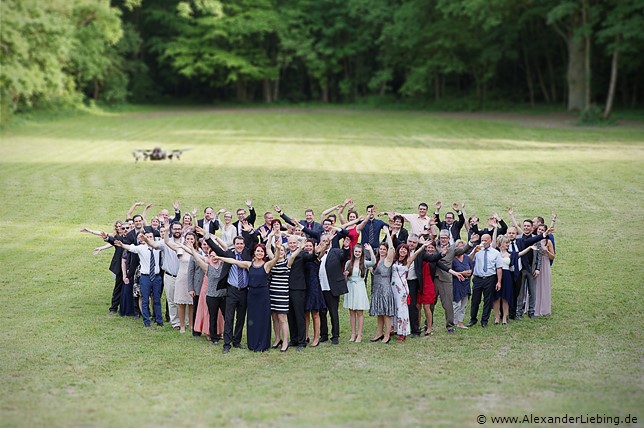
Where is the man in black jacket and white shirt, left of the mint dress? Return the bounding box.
[320,234,349,345]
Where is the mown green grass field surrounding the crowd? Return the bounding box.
[0,108,644,427]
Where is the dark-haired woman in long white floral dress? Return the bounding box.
[391,244,425,342]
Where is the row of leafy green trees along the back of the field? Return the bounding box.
[0,0,644,121]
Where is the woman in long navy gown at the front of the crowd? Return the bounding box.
[218,243,280,352]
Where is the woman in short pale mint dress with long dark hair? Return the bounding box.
[344,244,376,342]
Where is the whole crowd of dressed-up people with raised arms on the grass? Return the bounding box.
[81,198,556,353]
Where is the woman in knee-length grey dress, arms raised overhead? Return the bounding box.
[369,227,396,343]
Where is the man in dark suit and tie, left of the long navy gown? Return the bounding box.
[206,231,252,354]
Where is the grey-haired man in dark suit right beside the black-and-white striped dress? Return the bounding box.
[287,235,317,351]
